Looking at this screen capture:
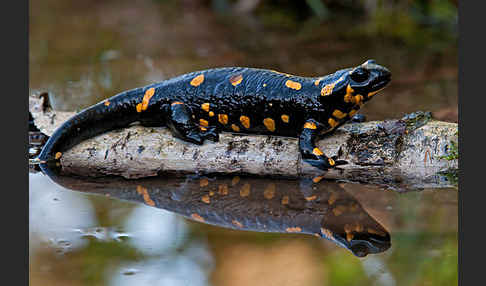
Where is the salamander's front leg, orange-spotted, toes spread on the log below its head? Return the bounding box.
[299,119,347,170]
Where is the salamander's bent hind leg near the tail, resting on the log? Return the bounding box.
[167,101,219,145]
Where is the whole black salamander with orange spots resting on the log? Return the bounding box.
[37,60,391,170]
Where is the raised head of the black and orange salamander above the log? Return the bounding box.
[321,60,391,105]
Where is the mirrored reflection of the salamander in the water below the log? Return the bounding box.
[44,165,391,257]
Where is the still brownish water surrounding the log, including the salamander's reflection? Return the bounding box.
[29,0,458,285]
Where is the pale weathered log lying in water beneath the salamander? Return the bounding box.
[30,92,458,187]
